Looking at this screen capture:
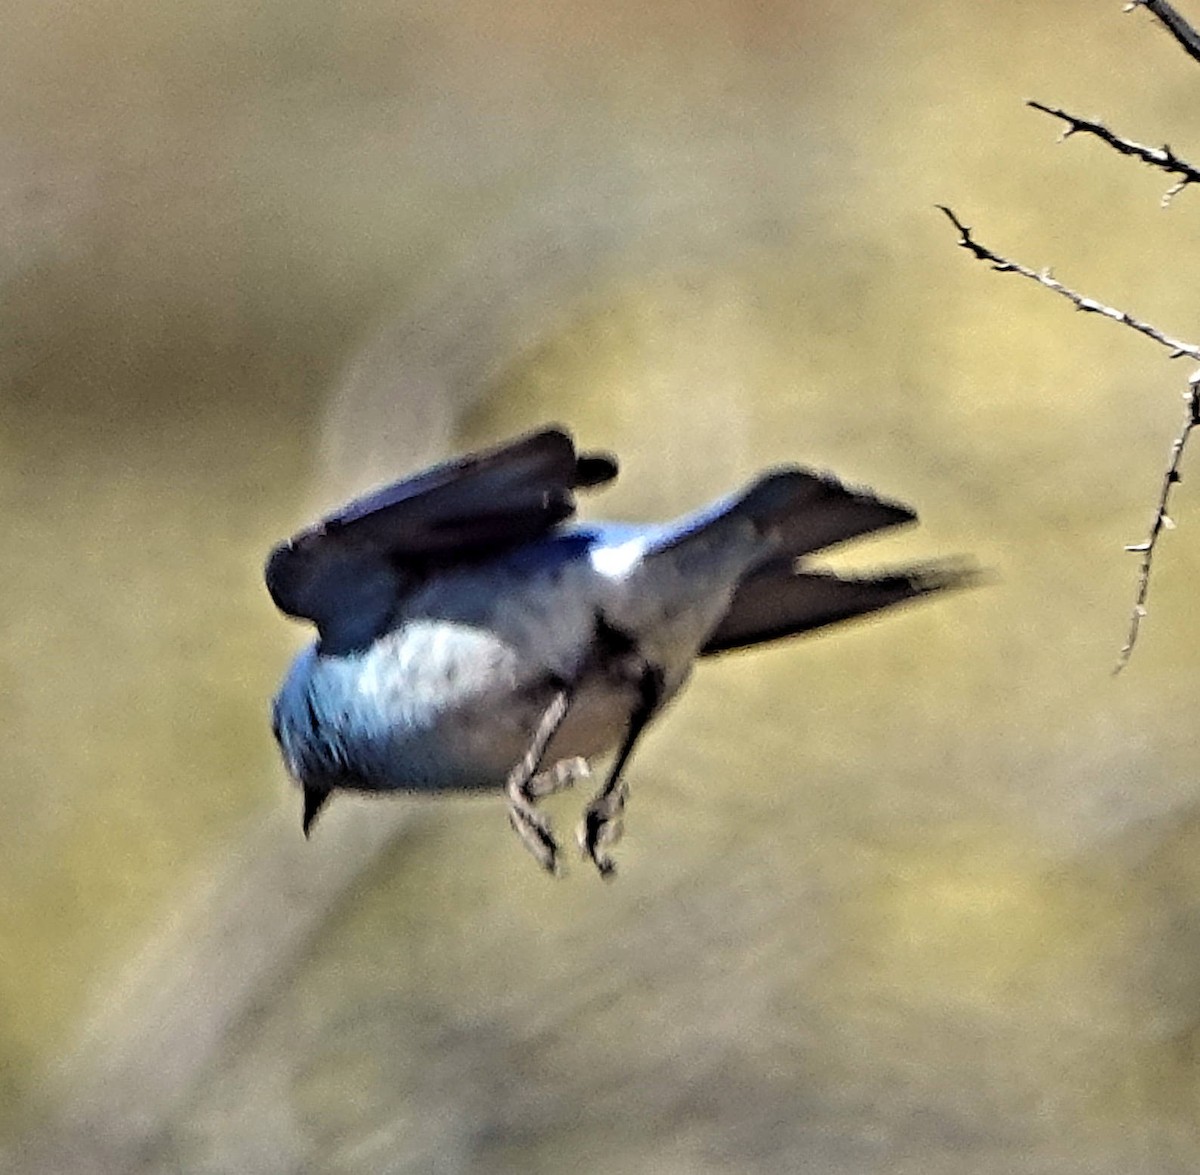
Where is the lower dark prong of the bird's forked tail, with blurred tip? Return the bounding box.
[701,559,979,657]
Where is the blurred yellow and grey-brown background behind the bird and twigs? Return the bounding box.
[0,0,1200,1175]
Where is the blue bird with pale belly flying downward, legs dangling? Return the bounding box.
[264,425,977,876]
